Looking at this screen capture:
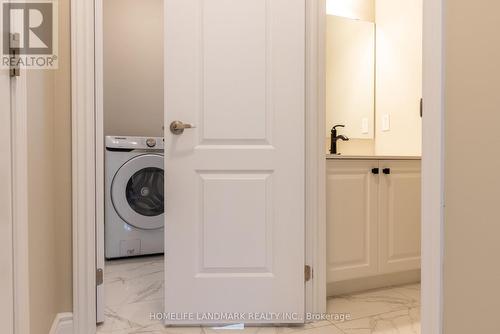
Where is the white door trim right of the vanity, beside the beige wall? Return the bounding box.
[422,0,444,334]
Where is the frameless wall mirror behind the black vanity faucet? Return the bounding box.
[326,15,375,139]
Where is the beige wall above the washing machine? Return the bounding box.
[103,0,163,136]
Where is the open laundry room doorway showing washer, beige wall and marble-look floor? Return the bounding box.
[95,0,165,326]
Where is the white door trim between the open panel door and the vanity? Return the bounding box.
[305,0,326,314]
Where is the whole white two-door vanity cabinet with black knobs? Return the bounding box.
[326,157,421,283]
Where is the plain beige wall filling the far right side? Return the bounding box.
[444,0,500,334]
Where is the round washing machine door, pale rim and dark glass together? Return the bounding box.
[111,154,164,230]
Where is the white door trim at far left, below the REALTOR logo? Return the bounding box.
[2,64,30,334]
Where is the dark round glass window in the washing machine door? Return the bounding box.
[125,167,164,217]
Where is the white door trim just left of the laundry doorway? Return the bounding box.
[71,0,96,334]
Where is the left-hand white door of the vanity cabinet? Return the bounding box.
[326,160,379,282]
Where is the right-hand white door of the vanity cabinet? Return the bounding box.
[379,160,421,273]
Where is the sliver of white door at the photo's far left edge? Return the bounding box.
[0,36,14,333]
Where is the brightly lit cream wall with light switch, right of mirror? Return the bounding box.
[375,0,423,155]
